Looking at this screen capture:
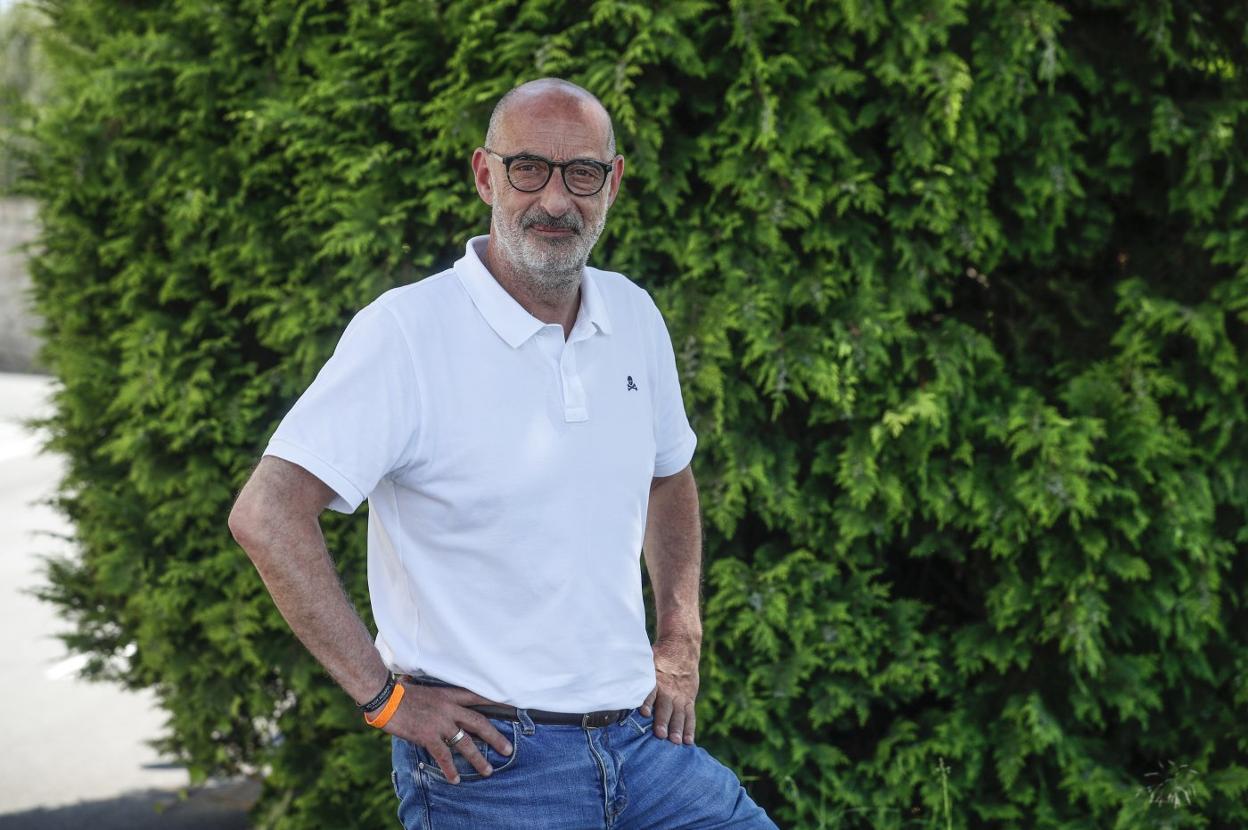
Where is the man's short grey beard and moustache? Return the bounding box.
[490,200,607,306]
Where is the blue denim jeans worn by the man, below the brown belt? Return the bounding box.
[392,709,775,830]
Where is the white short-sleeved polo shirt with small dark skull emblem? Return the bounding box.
[265,236,696,711]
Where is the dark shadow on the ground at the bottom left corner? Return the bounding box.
[0,779,260,830]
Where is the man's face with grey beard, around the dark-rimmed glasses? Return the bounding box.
[474,99,624,287]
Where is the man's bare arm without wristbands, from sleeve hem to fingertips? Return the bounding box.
[641,467,701,744]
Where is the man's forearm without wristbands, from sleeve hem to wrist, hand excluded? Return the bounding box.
[643,468,701,657]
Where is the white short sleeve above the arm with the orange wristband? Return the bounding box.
[265,302,419,513]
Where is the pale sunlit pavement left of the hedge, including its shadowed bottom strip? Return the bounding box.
[0,373,258,830]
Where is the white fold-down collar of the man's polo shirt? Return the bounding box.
[454,235,612,348]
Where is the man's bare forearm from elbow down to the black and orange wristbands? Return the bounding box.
[236,499,388,703]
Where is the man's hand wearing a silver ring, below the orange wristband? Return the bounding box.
[384,683,512,784]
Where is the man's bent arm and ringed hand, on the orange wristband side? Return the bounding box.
[230,456,512,784]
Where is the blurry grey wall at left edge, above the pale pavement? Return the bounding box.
[0,198,40,372]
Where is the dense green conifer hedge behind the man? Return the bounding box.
[25,0,1248,830]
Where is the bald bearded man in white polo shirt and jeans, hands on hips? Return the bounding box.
[230,79,775,830]
